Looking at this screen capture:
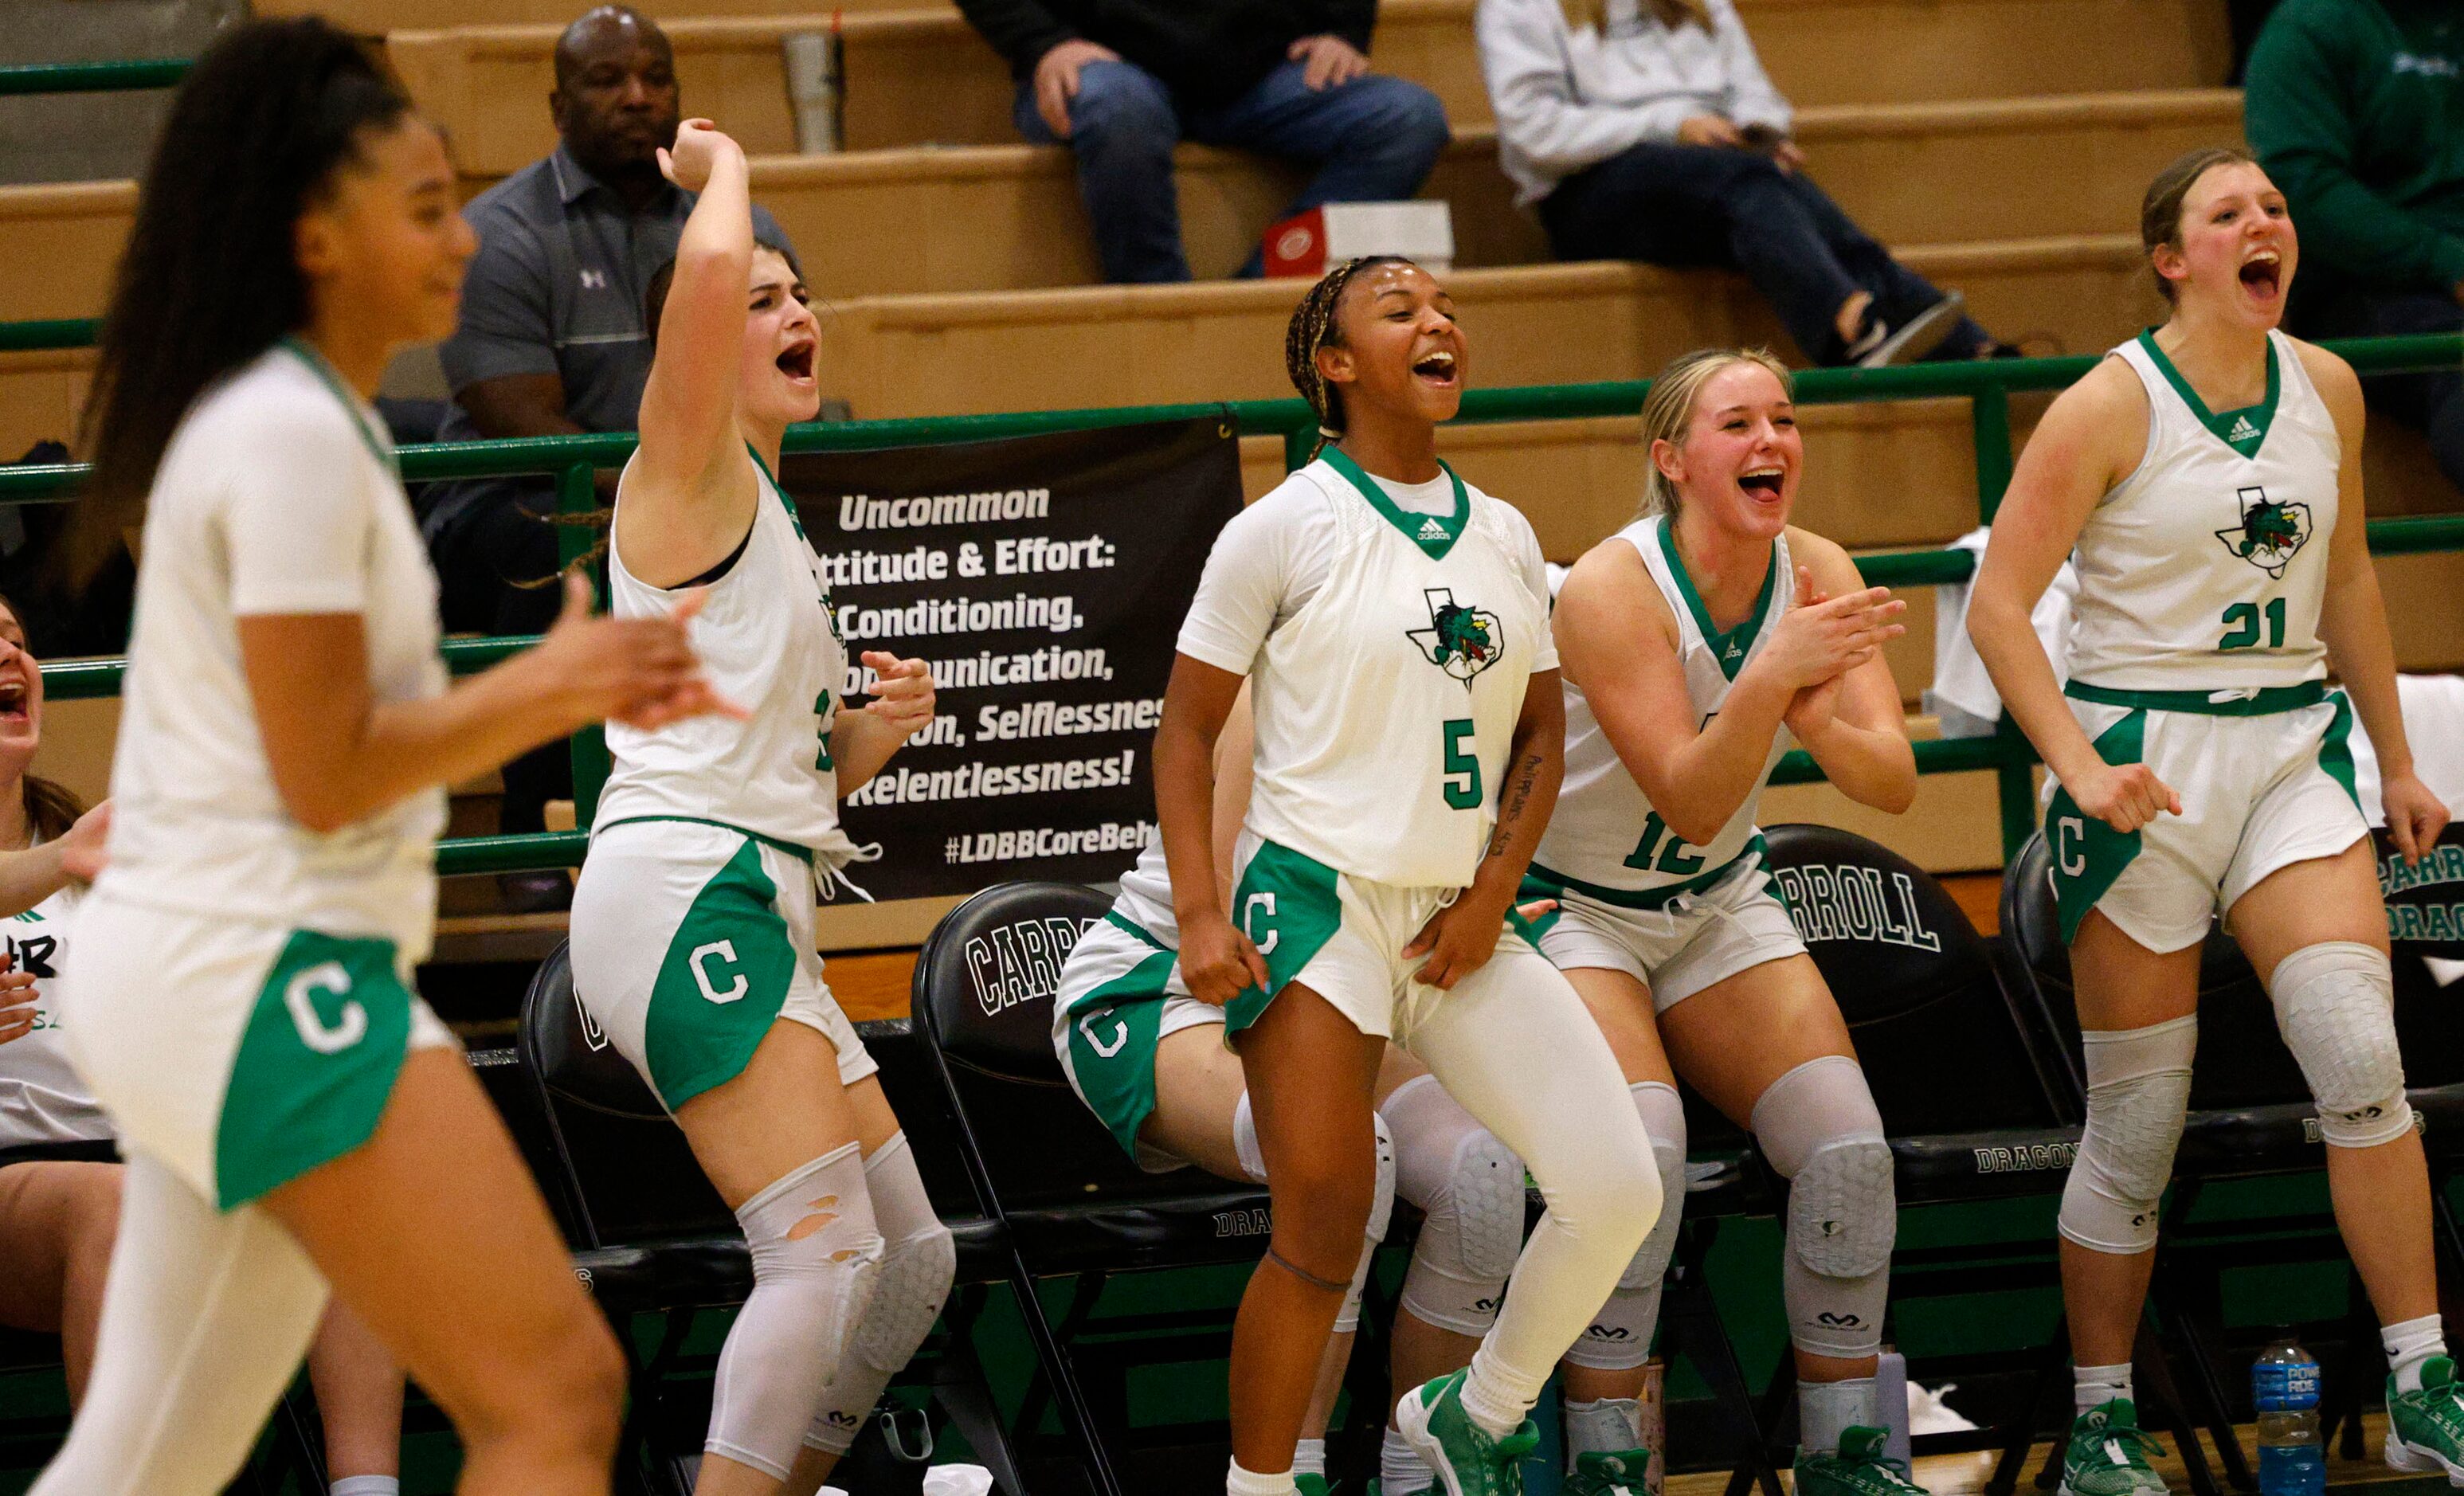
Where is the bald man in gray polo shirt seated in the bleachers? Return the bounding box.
[421,5,789,907]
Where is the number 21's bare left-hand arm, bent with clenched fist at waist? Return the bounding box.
[1968,358,2180,833]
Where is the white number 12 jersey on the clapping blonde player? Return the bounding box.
[1533,515,1796,892]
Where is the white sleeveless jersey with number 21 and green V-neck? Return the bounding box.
[2070,333,2343,690]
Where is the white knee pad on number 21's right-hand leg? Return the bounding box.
[2267,939,2412,1149]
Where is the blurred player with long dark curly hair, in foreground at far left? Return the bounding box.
[34,20,712,1496]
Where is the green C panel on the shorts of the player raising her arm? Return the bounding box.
[643,838,796,1111]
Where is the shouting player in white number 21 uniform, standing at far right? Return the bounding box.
[1968,151,2464,1496]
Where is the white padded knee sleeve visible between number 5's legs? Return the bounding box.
[1380,1075,1522,1336]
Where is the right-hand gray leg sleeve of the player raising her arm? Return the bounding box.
[803,1134,958,1454]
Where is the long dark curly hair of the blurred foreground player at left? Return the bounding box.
[61,18,412,584]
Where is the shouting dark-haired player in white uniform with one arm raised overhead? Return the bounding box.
[572,121,956,1496]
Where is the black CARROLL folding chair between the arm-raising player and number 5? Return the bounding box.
[915,883,1301,1496]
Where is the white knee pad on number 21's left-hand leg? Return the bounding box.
[2060,1016,2198,1257]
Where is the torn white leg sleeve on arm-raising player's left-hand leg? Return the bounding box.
[705,1144,882,1481]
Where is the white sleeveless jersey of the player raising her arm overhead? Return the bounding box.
[593,458,855,867]
